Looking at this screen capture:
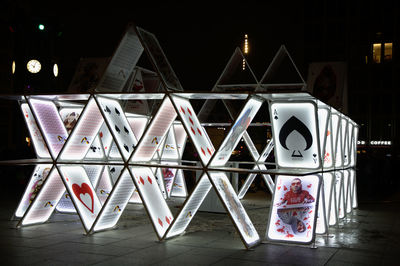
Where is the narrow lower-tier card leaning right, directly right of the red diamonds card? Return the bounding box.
[166,174,212,238]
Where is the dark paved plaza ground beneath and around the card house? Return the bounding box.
[0,187,400,266]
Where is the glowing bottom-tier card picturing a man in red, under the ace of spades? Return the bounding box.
[267,175,321,243]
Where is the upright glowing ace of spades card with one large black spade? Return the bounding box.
[271,102,321,169]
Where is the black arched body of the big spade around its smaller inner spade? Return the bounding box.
[279,116,313,150]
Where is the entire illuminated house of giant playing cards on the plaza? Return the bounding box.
[3,26,358,248]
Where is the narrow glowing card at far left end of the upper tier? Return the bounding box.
[21,103,50,158]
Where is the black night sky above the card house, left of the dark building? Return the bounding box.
[4,1,306,90]
